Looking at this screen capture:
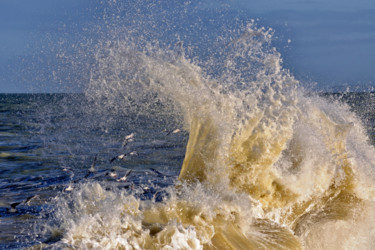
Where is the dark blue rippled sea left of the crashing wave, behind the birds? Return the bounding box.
[0,94,187,249]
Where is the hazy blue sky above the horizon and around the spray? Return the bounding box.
[0,0,375,93]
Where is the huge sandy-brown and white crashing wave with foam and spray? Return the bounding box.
[31,5,375,249]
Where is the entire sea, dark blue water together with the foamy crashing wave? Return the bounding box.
[0,3,375,249]
